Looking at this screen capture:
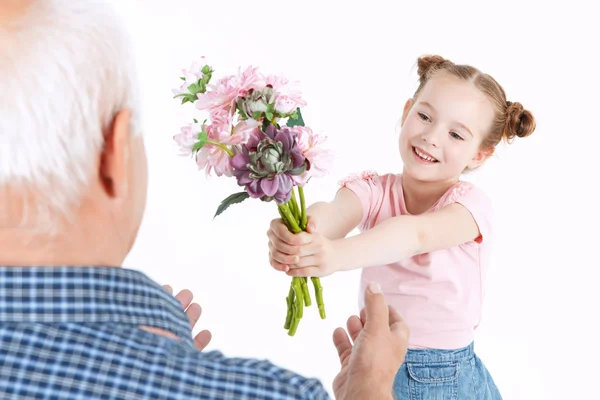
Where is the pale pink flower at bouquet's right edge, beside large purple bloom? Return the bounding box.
[292,126,333,185]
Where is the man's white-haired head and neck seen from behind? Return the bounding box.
[0,0,147,265]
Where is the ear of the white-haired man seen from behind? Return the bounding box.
[99,110,131,198]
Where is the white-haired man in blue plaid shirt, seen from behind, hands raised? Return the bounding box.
[0,0,408,400]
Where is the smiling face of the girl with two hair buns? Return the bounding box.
[399,71,494,182]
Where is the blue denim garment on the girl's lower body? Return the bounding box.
[394,343,502,400]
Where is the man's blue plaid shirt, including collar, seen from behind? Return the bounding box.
[0,267,329,400]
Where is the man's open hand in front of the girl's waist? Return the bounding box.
[333,283,409,400]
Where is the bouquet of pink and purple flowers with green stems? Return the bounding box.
[173,57,332,336]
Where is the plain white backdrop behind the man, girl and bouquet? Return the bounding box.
[115,0,600,400]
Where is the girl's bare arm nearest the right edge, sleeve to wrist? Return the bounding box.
[332,200,480,271]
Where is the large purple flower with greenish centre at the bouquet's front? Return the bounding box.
[231,125,306,204]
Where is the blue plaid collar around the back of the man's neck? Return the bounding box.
[0,266,194,347]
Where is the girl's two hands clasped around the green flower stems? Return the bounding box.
[267,216,340,278]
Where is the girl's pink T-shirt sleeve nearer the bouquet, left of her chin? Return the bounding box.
[339,171,386,231]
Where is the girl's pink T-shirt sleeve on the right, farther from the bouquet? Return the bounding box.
[444,182,494,243]
